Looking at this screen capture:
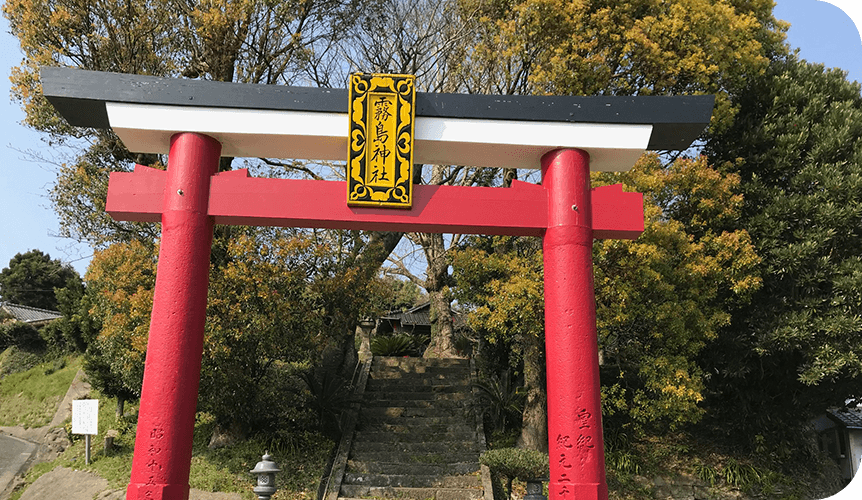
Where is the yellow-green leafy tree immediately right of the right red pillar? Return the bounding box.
[594,155,761,429]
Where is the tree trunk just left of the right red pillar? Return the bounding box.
[518,335,548,452]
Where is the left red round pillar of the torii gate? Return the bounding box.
[126,133,221,500]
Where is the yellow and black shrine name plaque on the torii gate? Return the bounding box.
[347,73,416,208]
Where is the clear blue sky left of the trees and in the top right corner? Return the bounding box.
[0,0,862,282]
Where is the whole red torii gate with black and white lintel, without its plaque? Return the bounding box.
[42,68,713,500]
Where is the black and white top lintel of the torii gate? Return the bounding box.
[41,68,714,171]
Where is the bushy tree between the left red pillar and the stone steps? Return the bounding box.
[199,228,381,433]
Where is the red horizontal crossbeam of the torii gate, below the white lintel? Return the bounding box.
[106,167,643,239]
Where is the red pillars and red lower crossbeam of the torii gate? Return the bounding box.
[106,137,643,500]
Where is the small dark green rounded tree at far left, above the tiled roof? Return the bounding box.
[0,250,81,311]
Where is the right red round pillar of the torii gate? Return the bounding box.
[542,149,608,500]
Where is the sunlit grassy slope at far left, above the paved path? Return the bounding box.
[0,348,81,428]
